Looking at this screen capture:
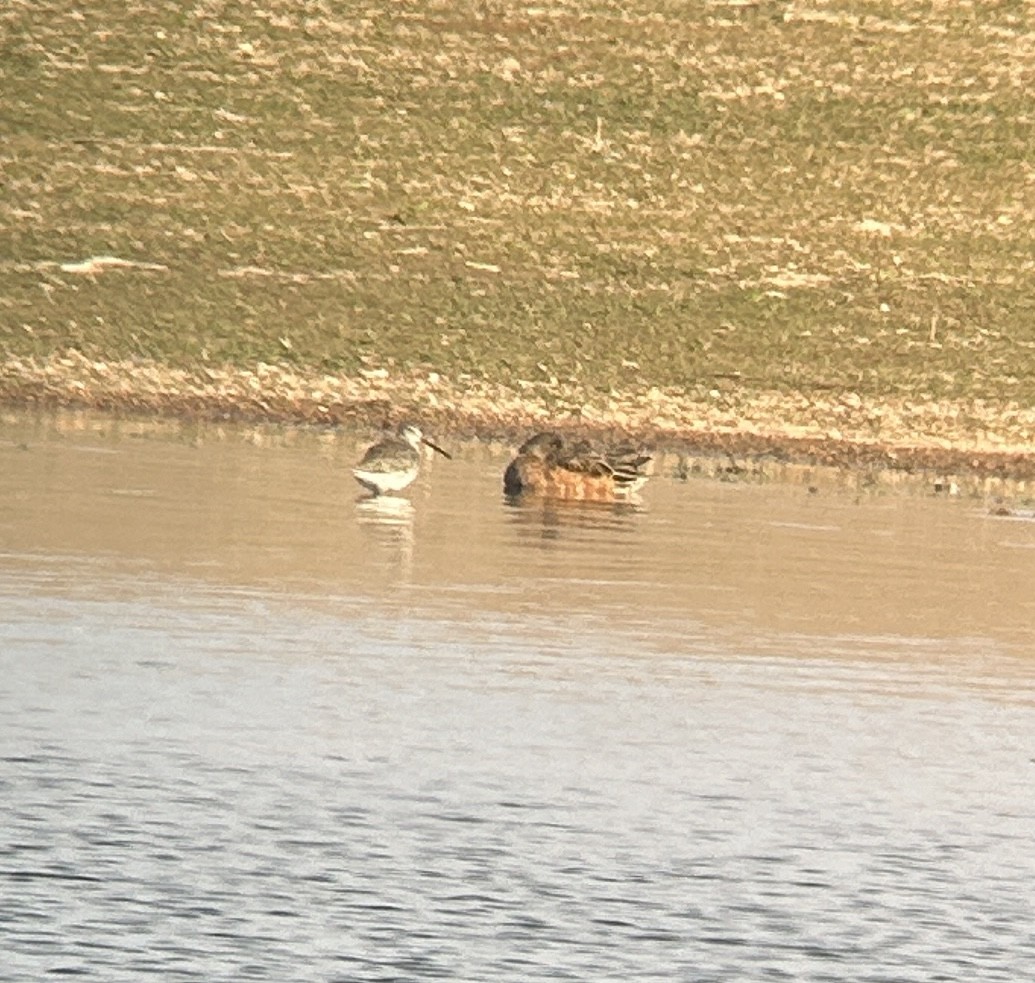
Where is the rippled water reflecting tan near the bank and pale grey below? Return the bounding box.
[0,415,1035,983]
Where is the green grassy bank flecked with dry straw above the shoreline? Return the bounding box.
[0,0,1035,461]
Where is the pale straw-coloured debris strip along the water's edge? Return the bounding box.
[6,350,1035,479]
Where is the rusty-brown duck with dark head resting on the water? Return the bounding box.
[503,430,651,502]
